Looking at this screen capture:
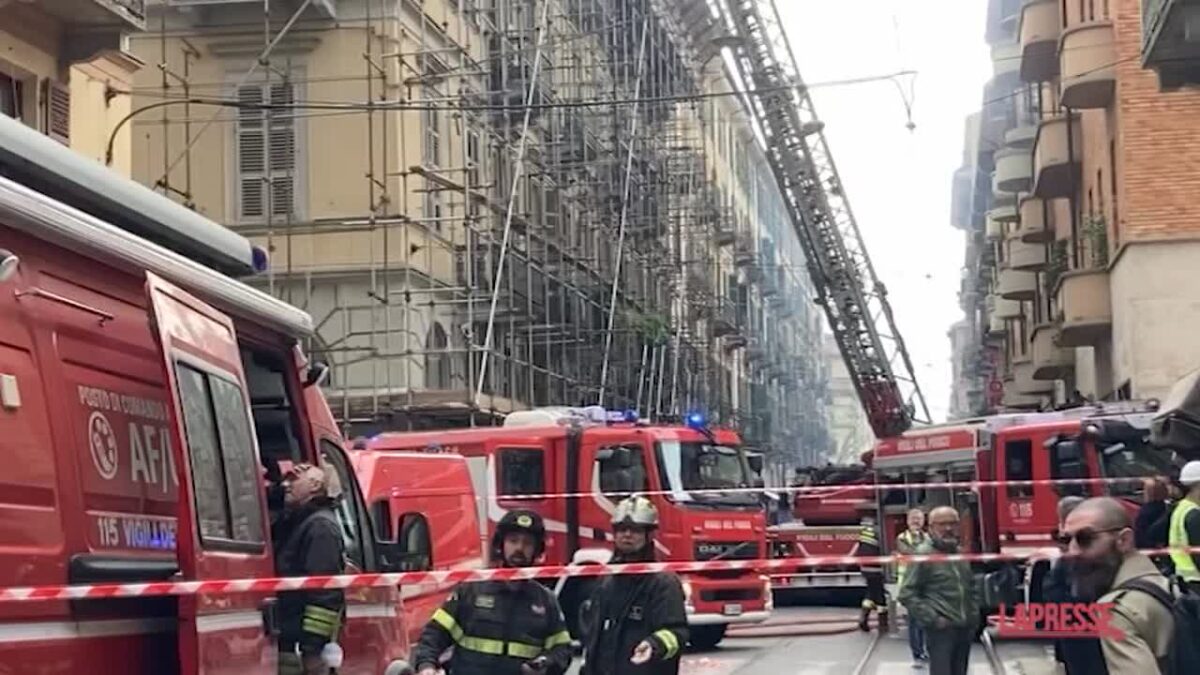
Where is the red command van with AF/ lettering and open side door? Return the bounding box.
[0,115,407,675]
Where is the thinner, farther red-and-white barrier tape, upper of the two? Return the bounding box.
[487,476,1153,502]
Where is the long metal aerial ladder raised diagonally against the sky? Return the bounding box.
[716,0,930,438]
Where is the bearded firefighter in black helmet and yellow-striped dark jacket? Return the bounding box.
[413,510,571,675]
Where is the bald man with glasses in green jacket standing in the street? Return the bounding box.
[900,507,979,675]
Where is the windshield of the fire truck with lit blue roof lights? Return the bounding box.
[659,441,758,506]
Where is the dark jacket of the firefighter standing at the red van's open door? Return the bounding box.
[274,504,346,653]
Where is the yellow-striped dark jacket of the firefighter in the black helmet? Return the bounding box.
[413,580,571,675]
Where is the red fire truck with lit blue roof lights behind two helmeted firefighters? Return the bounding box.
[371,407,773,646]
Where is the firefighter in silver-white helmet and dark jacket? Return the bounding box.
[583,496,689,675]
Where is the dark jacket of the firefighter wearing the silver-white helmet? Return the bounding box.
[583,572,689,675]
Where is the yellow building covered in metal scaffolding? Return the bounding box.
[128,0,828,456]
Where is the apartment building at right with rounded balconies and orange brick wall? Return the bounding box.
[956,0,1200,408]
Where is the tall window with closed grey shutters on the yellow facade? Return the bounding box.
[236,82,296,220]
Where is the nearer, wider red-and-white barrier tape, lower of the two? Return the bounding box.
[0,546,1200,603]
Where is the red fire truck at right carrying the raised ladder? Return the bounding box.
[782,401,1177,599]
